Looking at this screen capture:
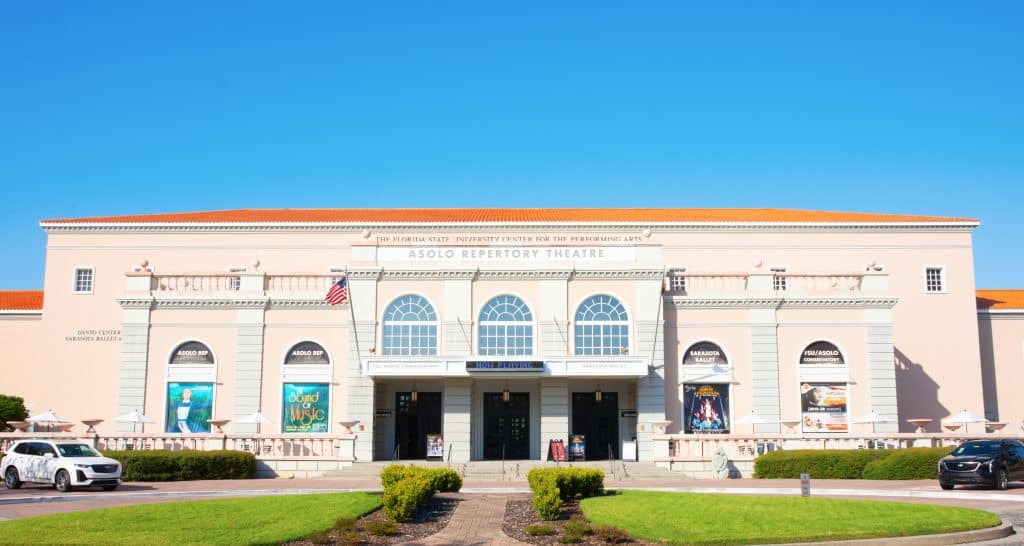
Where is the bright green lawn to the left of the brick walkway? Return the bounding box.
[0,493,381,546]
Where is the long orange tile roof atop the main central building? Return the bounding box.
[41,209,977,225]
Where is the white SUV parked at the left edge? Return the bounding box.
[0,439,121,493]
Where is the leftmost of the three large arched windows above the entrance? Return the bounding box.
[381,294,437,356]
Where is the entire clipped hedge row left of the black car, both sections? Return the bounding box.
[754,448,950,479]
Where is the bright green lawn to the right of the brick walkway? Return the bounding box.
[581,491,999,544]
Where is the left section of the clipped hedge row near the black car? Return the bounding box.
[754,450,892,479]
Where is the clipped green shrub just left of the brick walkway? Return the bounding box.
[381,464,462,521]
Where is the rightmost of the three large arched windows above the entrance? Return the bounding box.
[575,294,630,354]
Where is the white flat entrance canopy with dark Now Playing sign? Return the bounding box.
[362,356,649,377]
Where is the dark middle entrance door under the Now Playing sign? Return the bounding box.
[483,392,529,460]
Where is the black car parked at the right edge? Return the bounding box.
[939,439,1024,490]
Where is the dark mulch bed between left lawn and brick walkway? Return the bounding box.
[286,493,462,546]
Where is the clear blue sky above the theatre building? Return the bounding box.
[0,1,1024,288]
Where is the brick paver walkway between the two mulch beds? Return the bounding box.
[403,495,526,546]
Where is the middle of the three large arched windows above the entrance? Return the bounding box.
[478,295,534,356]
